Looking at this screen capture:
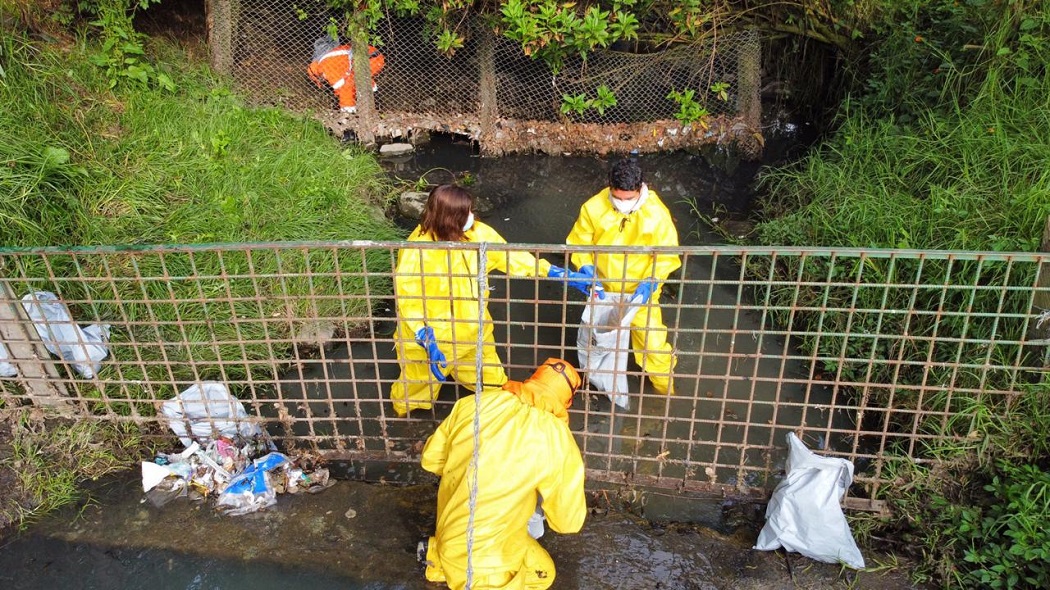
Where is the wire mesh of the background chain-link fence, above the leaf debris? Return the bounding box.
[219,0,760,151]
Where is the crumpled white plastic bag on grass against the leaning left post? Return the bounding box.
[22,291,109,379]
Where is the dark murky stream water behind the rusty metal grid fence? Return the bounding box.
[284,134,848,495]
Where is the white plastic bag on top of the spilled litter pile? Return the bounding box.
[161,381,263,446]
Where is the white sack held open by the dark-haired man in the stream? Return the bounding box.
[576,291,644,409]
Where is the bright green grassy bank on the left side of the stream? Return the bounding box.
[0,15,401,528]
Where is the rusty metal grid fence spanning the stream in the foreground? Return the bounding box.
[0,243,1050,507]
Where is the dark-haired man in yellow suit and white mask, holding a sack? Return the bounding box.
[565,159,681,394]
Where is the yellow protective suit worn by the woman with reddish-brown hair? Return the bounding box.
[391,222,550,416]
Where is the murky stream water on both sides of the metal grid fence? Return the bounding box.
[0,139,923,590]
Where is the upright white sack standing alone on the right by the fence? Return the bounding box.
[755,433,864,569]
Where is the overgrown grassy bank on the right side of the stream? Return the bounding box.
[758,2,1050,588]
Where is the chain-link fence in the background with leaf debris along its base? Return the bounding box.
[209,0,761,153]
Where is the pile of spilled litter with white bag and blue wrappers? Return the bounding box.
[142,381,334,515]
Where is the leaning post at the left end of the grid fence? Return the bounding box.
[0,281,72,409]
